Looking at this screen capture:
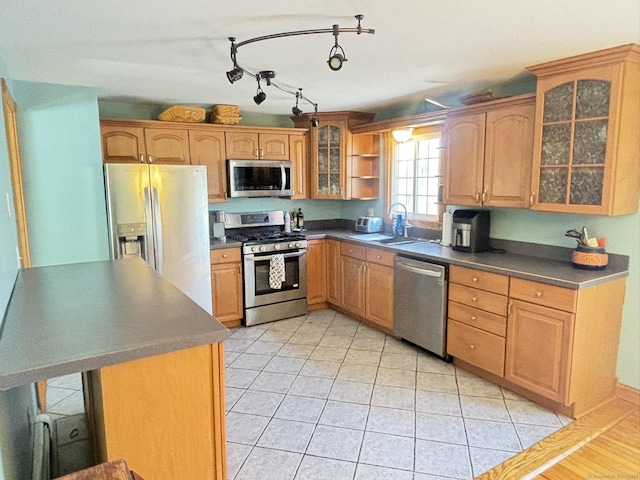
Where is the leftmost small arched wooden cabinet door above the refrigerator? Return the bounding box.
[100,125,146,163]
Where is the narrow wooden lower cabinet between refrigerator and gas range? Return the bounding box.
[210,248,243,326]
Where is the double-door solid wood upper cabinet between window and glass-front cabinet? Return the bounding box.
[444,95,535,208]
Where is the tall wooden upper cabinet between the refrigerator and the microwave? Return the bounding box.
[189,130,227,202]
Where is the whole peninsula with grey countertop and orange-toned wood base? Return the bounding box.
[0,259,229,480]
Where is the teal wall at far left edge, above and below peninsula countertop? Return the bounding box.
[0,51,35,480]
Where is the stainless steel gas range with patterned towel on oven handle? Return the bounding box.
[225,210,308,326]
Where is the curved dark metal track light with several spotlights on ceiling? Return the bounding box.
[227,15,376,112]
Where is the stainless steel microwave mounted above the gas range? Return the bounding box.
[227,160,293,197]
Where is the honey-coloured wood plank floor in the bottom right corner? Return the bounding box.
[478,399,640,480]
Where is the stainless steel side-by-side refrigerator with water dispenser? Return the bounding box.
[104,163,212,314]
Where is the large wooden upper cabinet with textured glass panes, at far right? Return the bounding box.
[528,44,640,215]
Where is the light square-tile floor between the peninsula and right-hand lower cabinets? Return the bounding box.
[225,310,571,480]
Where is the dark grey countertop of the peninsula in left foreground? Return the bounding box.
[0,259,229,390]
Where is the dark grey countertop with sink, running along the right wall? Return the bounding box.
[306,229,629,290]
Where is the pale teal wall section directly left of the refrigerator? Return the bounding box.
[14,82,109,266]
